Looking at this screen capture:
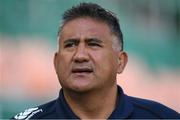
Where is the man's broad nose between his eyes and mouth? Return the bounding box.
[74,43,89,63]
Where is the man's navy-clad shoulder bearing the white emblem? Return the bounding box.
[12,100,56,120]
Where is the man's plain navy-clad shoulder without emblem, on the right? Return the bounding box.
[127,96,180,118]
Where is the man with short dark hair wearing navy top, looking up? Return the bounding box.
[11,3,180,119]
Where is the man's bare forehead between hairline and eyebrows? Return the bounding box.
[60,17,111,39]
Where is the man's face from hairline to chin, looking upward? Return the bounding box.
[54,18,126,92]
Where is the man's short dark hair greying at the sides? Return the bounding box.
[58,3,123,50]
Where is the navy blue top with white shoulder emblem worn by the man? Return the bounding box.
[13,86,180,119]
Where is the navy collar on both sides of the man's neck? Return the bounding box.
[56,86,133,119]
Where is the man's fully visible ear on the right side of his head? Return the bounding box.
[117,51,128,74]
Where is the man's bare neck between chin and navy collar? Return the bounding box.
[64,85,117,119]
